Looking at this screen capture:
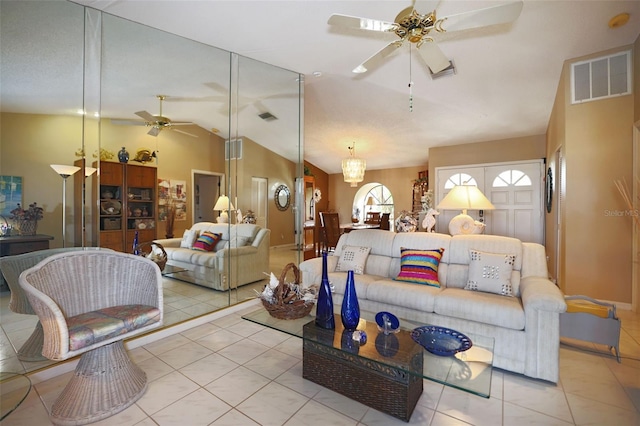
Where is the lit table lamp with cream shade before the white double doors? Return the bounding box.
[437,185,495,235]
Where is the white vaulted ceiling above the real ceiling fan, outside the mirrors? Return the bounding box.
[17,0,640,173]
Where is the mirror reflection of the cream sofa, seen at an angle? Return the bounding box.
[156,222,271,290]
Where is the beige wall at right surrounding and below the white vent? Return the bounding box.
[547,46,639,304]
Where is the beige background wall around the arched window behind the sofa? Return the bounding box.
[327,165,427,223]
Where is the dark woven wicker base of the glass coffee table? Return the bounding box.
[302,340,422,422]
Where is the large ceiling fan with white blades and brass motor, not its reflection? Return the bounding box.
[328,0,522,74]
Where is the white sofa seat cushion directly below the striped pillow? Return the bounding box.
[368,275,442,312]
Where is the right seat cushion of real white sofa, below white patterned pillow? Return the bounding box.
[436,286,525,330]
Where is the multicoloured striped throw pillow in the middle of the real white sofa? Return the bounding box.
[395,247,444,287]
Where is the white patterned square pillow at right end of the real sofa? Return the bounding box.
[465,250,516,296]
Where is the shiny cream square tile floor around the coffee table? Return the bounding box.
[2,302,640,426]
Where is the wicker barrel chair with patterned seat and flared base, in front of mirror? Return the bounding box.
[20,250,163,425]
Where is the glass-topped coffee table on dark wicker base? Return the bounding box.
[242,307,494,421]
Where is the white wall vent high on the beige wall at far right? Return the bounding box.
[571,50,632,104]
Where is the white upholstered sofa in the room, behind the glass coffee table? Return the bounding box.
[300,230,566,383]
